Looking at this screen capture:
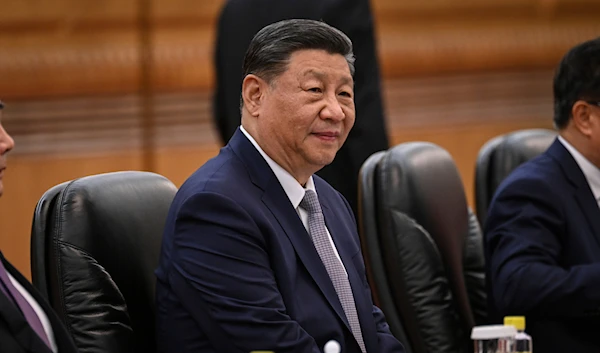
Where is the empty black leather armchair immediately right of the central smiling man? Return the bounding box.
[359,142,486,353]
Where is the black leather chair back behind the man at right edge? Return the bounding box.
[475,129,557,225]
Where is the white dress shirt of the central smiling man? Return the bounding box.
[240,126,348,275]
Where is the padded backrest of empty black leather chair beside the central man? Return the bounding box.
[377,142,474,327]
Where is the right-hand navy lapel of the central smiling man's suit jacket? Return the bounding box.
[317,190,377,351]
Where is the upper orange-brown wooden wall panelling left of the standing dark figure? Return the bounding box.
[0,0,222,100]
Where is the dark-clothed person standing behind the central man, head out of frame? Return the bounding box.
[213,0,389,216]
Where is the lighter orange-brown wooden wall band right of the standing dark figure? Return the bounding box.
[378,19,600,77]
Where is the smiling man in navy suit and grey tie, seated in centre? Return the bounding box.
[156,19,404,353]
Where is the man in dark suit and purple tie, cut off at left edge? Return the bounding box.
[0,102,77,353]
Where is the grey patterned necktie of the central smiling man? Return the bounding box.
[300,190,367,353]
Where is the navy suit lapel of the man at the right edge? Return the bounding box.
[547,139,600,246]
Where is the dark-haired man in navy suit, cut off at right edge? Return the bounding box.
[485,38,600,353]
